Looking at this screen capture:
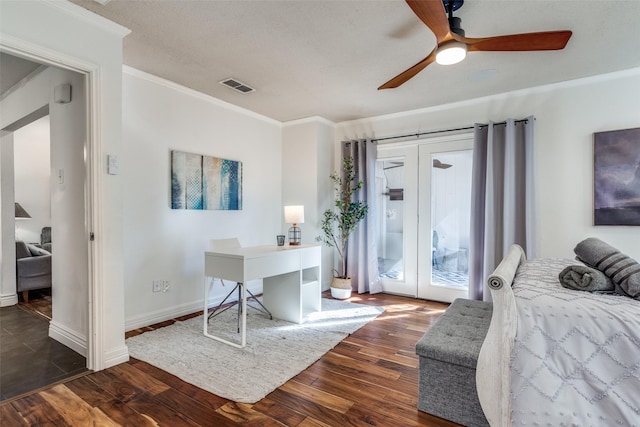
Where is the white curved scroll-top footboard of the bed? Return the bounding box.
[476,245,526,427]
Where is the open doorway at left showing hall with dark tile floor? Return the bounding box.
[0,53,91,399]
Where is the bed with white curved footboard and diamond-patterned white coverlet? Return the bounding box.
[476,245,640,427]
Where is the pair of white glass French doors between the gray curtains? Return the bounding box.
[376,134,473,302]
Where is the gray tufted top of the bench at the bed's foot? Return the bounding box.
[416,298,493,369]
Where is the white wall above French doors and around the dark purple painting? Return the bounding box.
[336,69,640,260]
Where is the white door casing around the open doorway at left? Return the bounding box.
[0,42,105,370]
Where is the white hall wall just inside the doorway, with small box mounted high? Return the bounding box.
[47,67,90,356]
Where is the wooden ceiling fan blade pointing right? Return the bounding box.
[453,31,571,52]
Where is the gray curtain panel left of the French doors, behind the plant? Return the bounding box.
[342,139,382,294]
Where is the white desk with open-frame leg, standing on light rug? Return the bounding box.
[203,245,322,348]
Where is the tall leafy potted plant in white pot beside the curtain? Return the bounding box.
[316,157,368,299]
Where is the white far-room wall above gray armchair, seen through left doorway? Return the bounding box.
[13,115,51,243]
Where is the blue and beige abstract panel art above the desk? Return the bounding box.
[171,151,242,210]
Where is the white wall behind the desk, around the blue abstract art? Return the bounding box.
[121,67,283,329]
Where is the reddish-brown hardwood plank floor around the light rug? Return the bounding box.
[0,294,457,427]
